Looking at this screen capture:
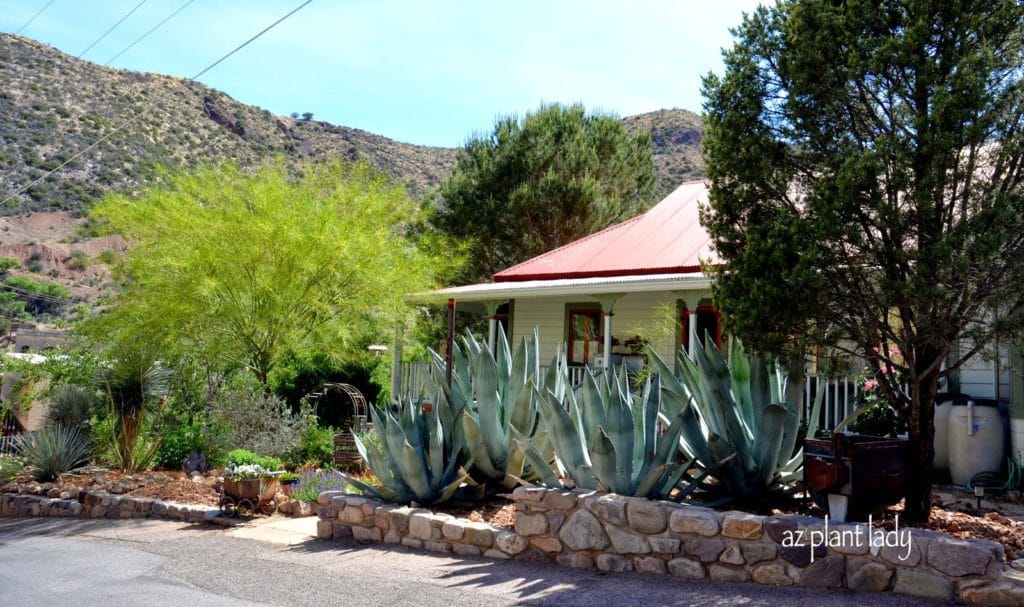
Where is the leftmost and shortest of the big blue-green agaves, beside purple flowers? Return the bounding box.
[345,398,469,506]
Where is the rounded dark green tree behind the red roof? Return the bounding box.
[431,104,655,280]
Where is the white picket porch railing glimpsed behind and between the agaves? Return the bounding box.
[401,361,861,430]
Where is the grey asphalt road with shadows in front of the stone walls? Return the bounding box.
[0,518,935,607]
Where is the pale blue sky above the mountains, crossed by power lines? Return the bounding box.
[0,0,760,146]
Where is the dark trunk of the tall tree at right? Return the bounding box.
[904,348,939,523]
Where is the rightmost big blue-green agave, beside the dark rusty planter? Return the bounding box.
[650,340,822,506]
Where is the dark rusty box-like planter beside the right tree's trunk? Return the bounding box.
[804,433,910,521]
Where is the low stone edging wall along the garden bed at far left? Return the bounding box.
[0,491,220,523]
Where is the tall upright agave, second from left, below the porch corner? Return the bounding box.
[431,329,541,489]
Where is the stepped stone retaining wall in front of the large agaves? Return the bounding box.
[317,487,1024,606]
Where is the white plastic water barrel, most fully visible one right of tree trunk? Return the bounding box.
[948,401,1004,485]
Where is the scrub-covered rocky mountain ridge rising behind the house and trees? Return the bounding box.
[0,34,702,215]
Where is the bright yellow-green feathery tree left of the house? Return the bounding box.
[83,163,461,389]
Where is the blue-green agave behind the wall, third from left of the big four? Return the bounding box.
[523,352,696,500]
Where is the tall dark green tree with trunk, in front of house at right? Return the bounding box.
[703,0,1024,521]
